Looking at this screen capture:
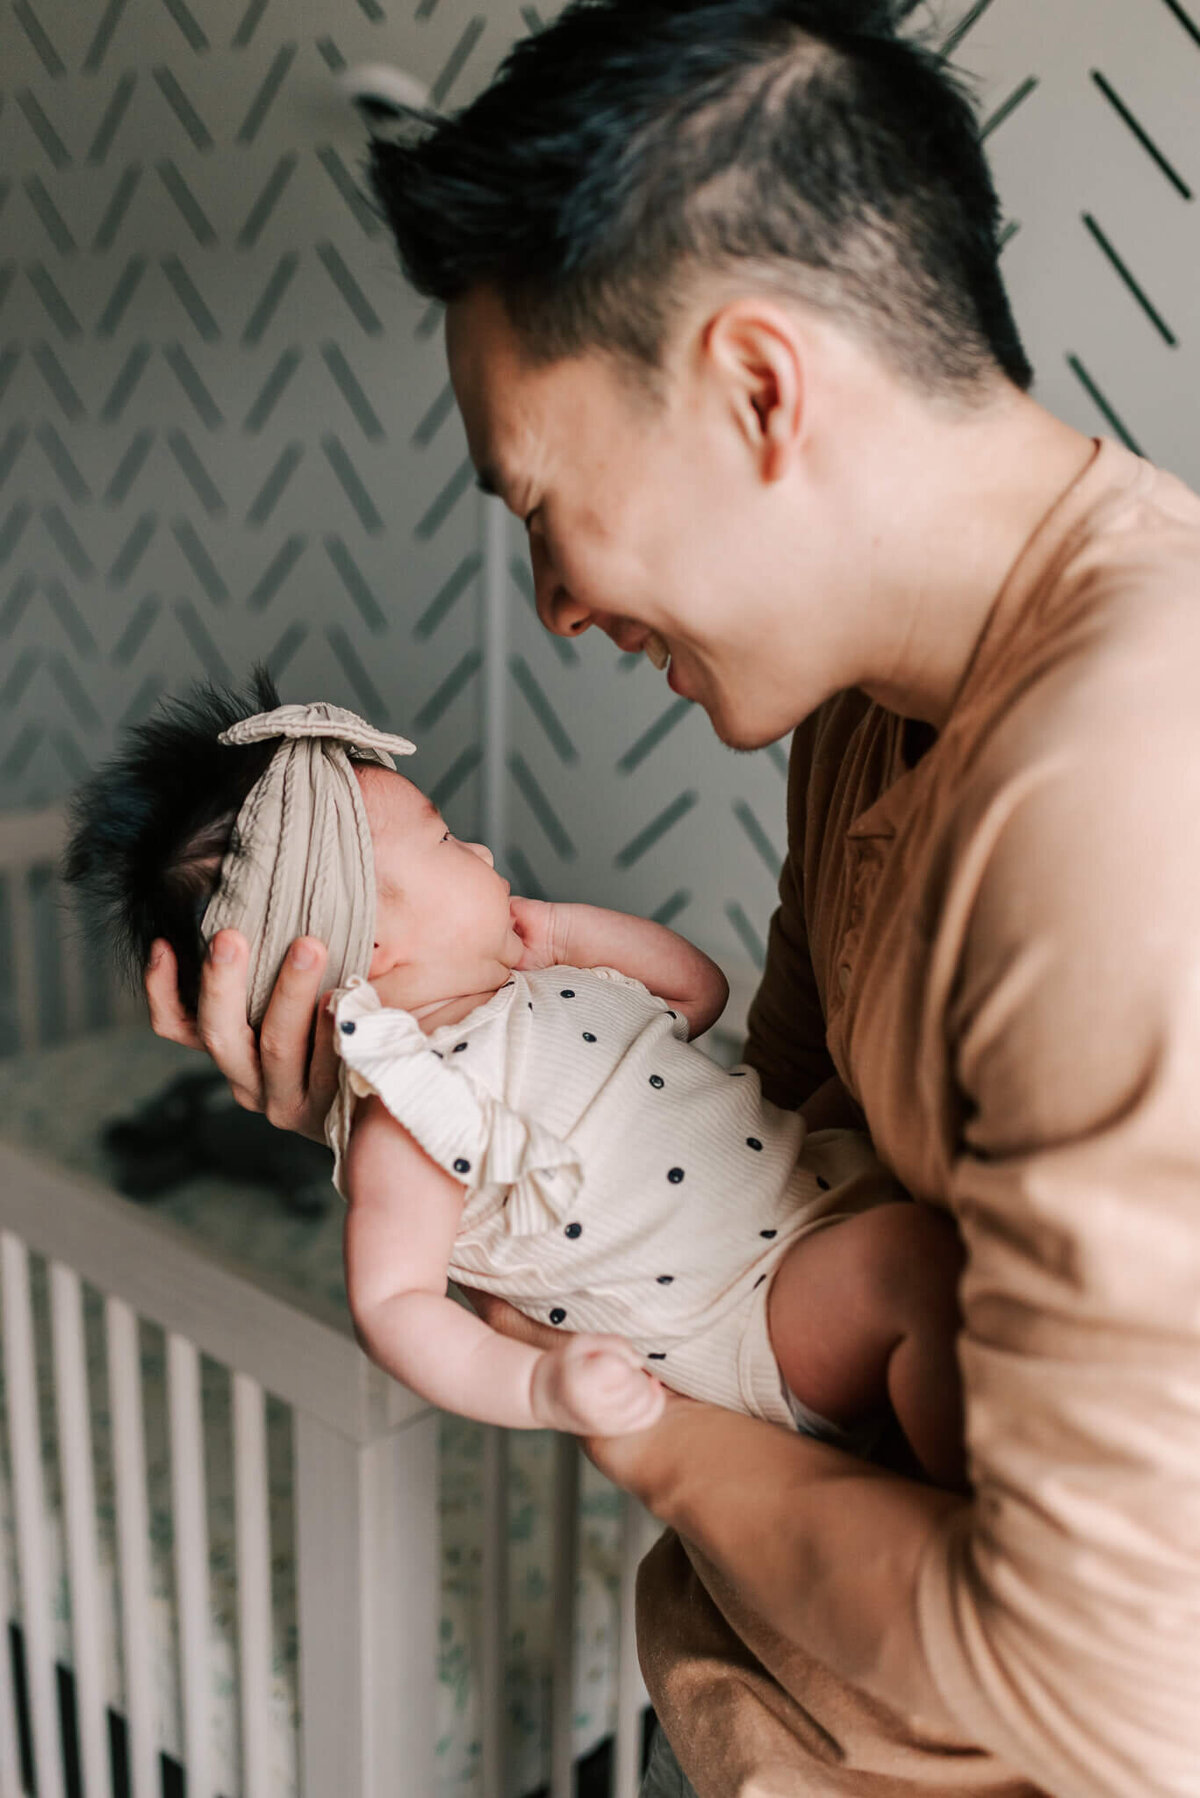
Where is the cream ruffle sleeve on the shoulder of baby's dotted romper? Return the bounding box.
[326,982,583,1235]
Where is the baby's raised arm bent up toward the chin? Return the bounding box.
[513,899,729,1036]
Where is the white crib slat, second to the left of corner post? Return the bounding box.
[167,1334,212,1798]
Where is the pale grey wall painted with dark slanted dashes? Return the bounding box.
[0,0,1200,985]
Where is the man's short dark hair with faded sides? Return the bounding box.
[371,0,1033,397]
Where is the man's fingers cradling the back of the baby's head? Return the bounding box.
[146,930,338,1142]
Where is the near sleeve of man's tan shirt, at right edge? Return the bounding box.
[918,744,1200,1798]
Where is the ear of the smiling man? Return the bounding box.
[703,298,804,482]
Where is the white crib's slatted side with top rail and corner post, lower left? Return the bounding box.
[0,1145,437,1798]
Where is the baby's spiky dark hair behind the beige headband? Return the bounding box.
[63,667,281,1014]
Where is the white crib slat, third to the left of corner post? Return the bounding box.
[104,1298,158,1798]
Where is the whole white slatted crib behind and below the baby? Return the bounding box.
[0,811,653,1798]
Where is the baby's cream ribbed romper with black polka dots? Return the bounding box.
[329,967,894,1424]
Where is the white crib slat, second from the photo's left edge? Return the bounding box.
[50,1260,112,1798]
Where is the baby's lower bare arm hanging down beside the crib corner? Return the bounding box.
[345,1099,664,1435]
